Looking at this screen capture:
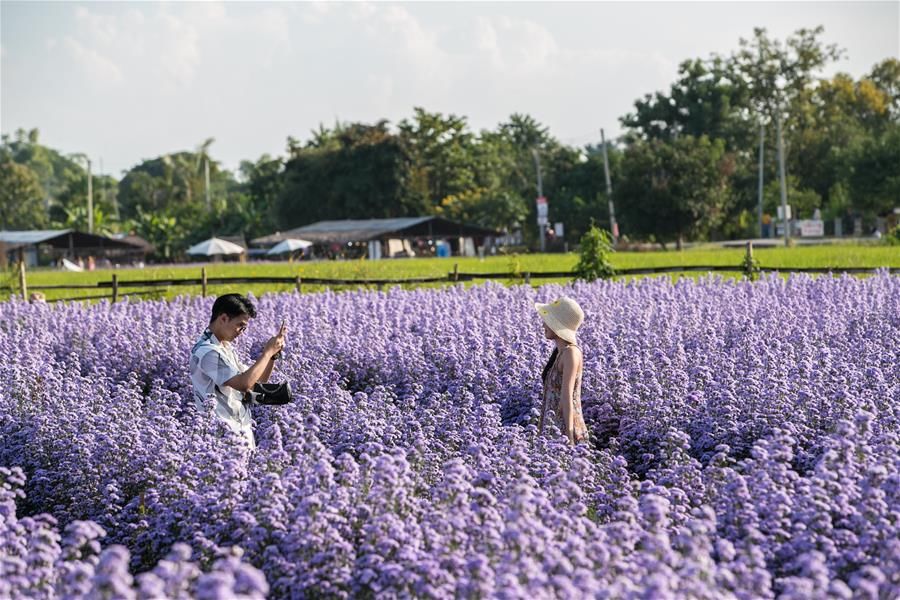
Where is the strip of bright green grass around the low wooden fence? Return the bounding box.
[0,245,900,300]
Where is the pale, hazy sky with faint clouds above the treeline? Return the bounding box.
[0,0,900,176]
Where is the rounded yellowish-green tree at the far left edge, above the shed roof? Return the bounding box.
[0,160,47,229]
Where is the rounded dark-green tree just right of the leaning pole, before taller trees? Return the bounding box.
[614,136,734,249]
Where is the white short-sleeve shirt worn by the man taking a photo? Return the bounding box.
[191,329,256,448]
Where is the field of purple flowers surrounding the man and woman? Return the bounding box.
[0,273,900,599]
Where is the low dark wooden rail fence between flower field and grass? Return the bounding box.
[0,244,900,302]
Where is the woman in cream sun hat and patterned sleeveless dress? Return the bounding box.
[534,296,588,445]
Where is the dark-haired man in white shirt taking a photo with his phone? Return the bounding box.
[191,294,285,448]
